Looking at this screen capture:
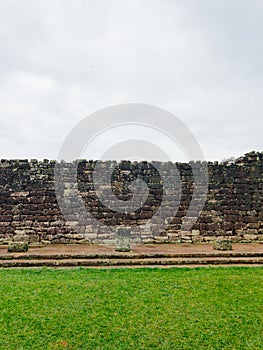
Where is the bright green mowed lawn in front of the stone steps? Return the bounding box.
[0,267,263,350]
